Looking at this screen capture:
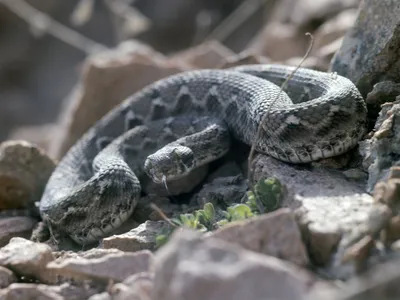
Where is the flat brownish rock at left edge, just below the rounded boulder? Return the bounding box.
[0,217,37,247]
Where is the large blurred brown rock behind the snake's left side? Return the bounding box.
[50,41,188,158]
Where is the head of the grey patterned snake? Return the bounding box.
[144,144,195,183]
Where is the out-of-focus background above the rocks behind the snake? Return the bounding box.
[0,0,359,148]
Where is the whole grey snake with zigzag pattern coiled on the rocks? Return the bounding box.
[39,64,367,245]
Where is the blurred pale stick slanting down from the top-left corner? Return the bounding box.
[0,0,107,54]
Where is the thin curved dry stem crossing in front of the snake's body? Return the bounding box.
[248,32,314,199]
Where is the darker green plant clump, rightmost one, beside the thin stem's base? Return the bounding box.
[246,177,284,214]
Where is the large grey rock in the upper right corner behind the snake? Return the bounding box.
[331,0,400,96]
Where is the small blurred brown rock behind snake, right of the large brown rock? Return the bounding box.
[170,41,235,69]
